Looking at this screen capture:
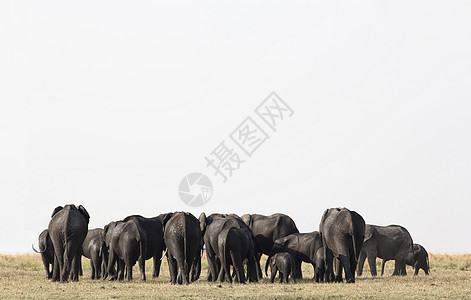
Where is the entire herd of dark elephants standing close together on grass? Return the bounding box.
[33,205,429,284]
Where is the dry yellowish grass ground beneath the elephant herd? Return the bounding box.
[0,254,471,299]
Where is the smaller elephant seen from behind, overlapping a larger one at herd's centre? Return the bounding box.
[218,227,256,283]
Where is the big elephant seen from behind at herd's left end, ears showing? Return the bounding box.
[48,204,90,282]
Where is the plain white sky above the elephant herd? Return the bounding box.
[0,1,471,253]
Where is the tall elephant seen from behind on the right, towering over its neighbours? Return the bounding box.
[319,208,365,283]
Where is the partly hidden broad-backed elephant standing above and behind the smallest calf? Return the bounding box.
[241,213,301,278]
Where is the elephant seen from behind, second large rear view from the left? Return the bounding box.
[108,220,147,281]
